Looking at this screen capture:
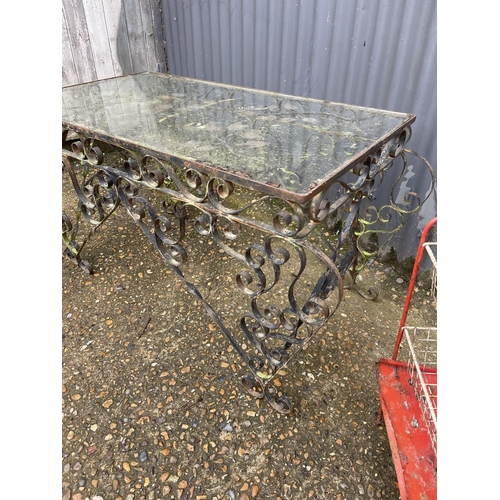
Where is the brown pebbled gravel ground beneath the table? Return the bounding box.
[62,169,432,500]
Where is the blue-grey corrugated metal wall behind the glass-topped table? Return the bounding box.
[160,0,437,260]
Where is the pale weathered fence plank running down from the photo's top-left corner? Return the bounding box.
[63,0,97,83]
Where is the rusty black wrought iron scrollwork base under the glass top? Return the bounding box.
[63,126,432,413]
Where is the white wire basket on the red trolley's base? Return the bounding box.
[403,326,437,453]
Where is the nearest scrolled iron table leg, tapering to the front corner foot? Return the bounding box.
[116,195,356,414]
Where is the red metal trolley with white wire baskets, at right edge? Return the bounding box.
[376,218,437,500]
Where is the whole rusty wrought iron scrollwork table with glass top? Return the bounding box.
[62,73,434,413]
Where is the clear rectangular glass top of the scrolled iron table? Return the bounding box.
[62,73,415,201]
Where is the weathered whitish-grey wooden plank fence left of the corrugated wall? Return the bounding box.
[62,0,166,87]
